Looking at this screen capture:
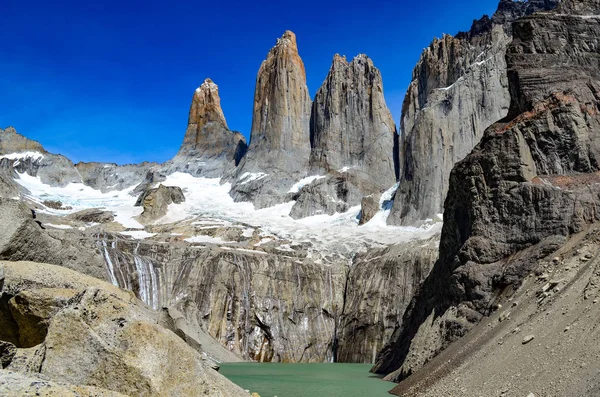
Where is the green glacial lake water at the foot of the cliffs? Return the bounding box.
[219,363,395,397]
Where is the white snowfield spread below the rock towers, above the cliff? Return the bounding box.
[11,172,441,252]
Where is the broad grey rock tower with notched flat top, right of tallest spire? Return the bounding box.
[310,54,396,189]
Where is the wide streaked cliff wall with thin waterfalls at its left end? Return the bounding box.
[100,240,346,362]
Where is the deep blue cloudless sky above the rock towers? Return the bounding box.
[0,0,498,163]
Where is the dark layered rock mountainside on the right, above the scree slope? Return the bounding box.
[374,1,600,380]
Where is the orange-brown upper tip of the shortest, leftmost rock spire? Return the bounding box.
[188,79,227,127]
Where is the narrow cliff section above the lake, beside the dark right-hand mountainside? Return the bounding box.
[336,239,439,363]
